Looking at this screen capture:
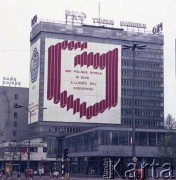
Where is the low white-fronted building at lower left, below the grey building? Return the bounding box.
[0,138,56,173]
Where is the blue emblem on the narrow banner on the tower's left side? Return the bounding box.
[30,48,39,83]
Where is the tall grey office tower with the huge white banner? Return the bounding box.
[29,21,164,158]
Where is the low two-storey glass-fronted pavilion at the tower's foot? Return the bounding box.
[64,127,175,176]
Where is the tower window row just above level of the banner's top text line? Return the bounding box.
[122,60,163,69]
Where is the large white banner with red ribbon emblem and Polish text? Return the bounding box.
[43,38,121,124]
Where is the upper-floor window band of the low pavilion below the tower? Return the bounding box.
[65,130,165,152]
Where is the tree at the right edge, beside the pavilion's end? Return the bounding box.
[158,114,176,167]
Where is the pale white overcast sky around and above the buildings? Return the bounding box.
[0,0,176,118]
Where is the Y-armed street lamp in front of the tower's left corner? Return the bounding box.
[14,103,47,169]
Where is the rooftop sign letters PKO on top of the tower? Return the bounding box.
[65,10,86,24]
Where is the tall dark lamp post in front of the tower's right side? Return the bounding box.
[122,43,146,158]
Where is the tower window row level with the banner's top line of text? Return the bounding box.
[122,69,163,78]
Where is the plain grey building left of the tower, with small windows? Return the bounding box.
[0,86,29,143]
